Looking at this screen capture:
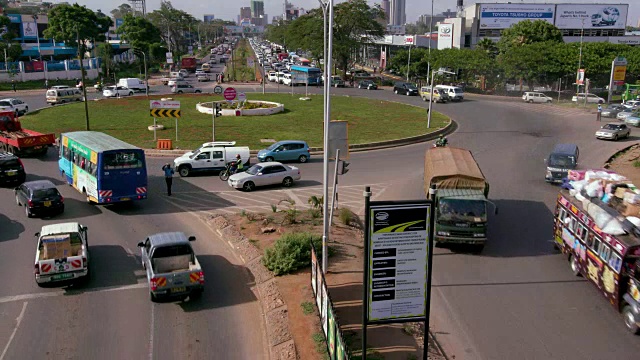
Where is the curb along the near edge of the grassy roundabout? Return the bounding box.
[144,118,458,157]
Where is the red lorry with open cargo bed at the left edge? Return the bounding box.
[0,111,56,156]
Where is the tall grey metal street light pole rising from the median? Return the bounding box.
[322,0,333,274]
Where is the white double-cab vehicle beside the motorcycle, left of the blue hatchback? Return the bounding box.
[173,141,251,177]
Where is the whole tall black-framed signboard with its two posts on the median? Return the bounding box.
[362,186,435,360]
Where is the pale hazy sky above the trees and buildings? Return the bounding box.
[61,0,640,26]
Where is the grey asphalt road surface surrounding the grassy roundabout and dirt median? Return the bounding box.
[0,77,640,360]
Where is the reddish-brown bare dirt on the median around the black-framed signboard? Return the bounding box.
[224,207,444,360]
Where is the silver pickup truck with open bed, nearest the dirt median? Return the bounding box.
[138,232,204,302]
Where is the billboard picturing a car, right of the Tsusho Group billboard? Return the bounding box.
[555,4,629,29]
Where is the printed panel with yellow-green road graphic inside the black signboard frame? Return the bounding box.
[367,202,431,321]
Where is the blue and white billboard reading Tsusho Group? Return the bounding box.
[480,4,555,29]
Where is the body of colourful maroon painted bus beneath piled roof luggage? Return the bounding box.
[554,190,640,334]
